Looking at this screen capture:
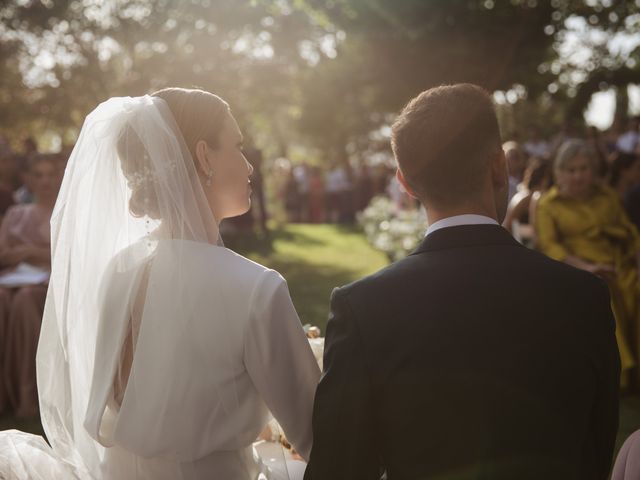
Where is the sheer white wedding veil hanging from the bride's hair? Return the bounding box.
[37,96,219,473]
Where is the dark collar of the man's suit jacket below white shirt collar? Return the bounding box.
[411,225,525,255]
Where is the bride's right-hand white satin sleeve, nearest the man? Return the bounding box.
[244,270,320,459]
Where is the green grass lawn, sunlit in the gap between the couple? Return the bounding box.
[0,225,640,460]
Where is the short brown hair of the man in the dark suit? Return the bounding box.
[391,83,502,207]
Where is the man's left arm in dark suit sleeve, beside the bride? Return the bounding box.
[304,290,380,480]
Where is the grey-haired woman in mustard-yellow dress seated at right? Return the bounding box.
[536,140,640,386]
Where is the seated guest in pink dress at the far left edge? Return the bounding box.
[0,155,61,417]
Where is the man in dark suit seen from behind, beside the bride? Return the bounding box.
[305,84,619,480]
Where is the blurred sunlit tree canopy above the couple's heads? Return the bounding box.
[0,0,640,161]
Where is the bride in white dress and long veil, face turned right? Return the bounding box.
[0,88,320,480]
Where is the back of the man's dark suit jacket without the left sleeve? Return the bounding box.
[338,226,617,480]
